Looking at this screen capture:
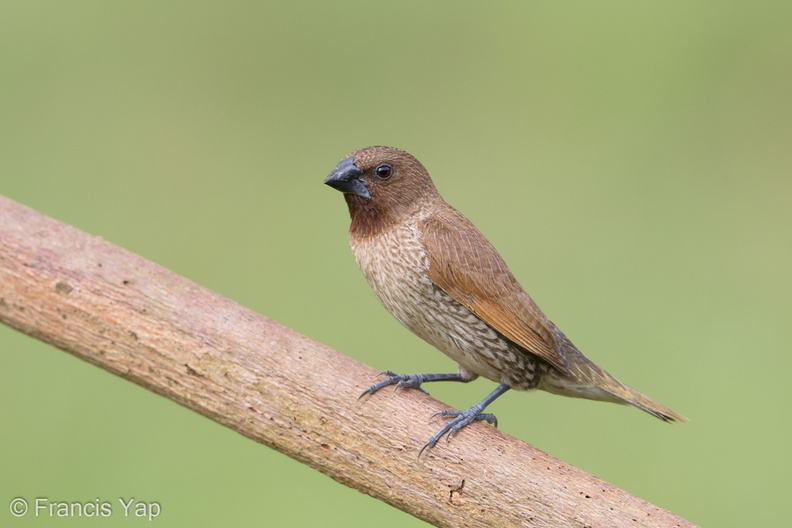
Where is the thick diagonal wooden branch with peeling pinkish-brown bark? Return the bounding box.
[0,197,693,528]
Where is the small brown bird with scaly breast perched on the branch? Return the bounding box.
[324,147,687,452]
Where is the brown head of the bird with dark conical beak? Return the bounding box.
[324,147,442,235]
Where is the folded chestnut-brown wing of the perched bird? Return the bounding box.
[421,207,569,373]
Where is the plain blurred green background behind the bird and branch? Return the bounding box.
[0,0,792,528]
